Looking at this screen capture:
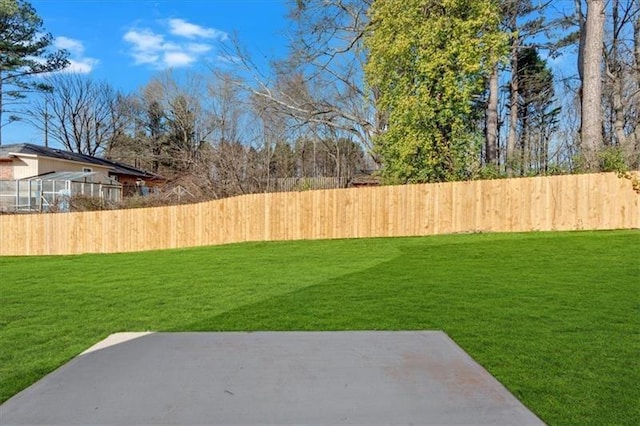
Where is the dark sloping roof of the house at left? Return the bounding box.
[0,143,164,180]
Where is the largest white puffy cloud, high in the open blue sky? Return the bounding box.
[122,19,227,69]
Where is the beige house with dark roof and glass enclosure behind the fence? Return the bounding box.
[0,143,166,211]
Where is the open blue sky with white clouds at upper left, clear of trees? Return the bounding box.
[3,0,287,144]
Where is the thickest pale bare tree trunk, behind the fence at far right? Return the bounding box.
[580,0,605,171]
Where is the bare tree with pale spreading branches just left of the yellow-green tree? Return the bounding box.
[225,0,386,165]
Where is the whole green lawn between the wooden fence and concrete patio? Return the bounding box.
[0,231,640,425]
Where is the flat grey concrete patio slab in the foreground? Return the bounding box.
[0,331,542,426]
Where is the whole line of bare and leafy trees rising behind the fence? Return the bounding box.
[0,0,640,197]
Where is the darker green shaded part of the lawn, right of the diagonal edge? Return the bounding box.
[180,237,638,423]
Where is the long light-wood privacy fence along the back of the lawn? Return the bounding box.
[0,173,640,255]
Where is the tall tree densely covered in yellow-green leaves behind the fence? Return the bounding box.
[365,0,507,182]
